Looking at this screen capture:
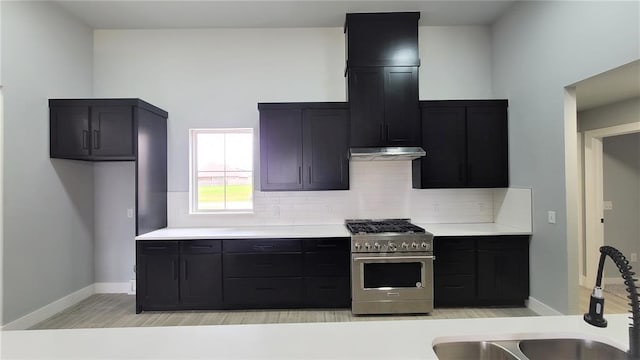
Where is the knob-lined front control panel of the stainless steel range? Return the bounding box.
[351,236,433,253]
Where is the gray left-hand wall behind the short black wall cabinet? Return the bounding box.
[1,1,94,324]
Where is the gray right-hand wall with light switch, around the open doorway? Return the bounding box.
[493,1,640,313]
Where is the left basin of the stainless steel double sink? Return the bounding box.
[433,341,519,360]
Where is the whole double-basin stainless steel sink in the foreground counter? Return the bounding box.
[433,338,627,360]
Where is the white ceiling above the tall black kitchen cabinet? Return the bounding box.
[55,0,515,29]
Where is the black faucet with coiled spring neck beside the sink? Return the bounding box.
[584,246,640,360]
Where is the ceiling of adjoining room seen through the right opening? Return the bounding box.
[575,60,640,111]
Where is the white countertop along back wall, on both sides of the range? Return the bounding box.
[136,223,531,240]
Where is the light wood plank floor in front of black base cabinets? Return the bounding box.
[31,288,628,329]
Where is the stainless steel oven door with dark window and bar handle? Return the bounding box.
[351,253,434,301]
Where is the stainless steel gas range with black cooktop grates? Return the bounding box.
[345,219,434,314]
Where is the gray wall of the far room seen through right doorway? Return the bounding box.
[602,133,640,279]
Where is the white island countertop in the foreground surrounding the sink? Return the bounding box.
[1,314,629,359]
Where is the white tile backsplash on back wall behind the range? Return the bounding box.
[168,161,494,227]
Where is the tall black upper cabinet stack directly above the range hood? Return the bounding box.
[345,12,420,147]
